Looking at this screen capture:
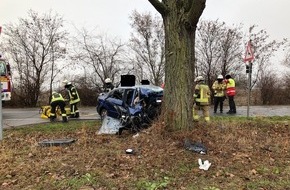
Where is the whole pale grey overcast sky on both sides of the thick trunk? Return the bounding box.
[0,0,290,40]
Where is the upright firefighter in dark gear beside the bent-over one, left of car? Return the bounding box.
[63,80,81,118]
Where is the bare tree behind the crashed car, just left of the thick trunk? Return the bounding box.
[130,11,165,85]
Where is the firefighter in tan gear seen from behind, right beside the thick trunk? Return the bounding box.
[193,76,210,122]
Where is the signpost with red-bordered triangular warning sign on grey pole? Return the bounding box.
[244,40,254,118]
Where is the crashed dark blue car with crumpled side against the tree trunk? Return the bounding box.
[97,85,163,133]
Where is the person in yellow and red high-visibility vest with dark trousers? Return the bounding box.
[225,75,237,114]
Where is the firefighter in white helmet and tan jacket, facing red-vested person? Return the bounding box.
[212,75,226,113]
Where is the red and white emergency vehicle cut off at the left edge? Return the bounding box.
[0,57,12,101]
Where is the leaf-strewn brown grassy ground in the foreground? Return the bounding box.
[0,119,290,190]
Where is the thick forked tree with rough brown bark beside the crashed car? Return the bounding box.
[148,0,206,130]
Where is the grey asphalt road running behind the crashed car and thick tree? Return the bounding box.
[2,106,290,128]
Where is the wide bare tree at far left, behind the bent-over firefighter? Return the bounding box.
[4,10,67,106]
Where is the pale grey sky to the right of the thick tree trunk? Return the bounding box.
[203,0,290,40]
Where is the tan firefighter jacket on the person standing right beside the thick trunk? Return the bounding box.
[194,84,210,105]
